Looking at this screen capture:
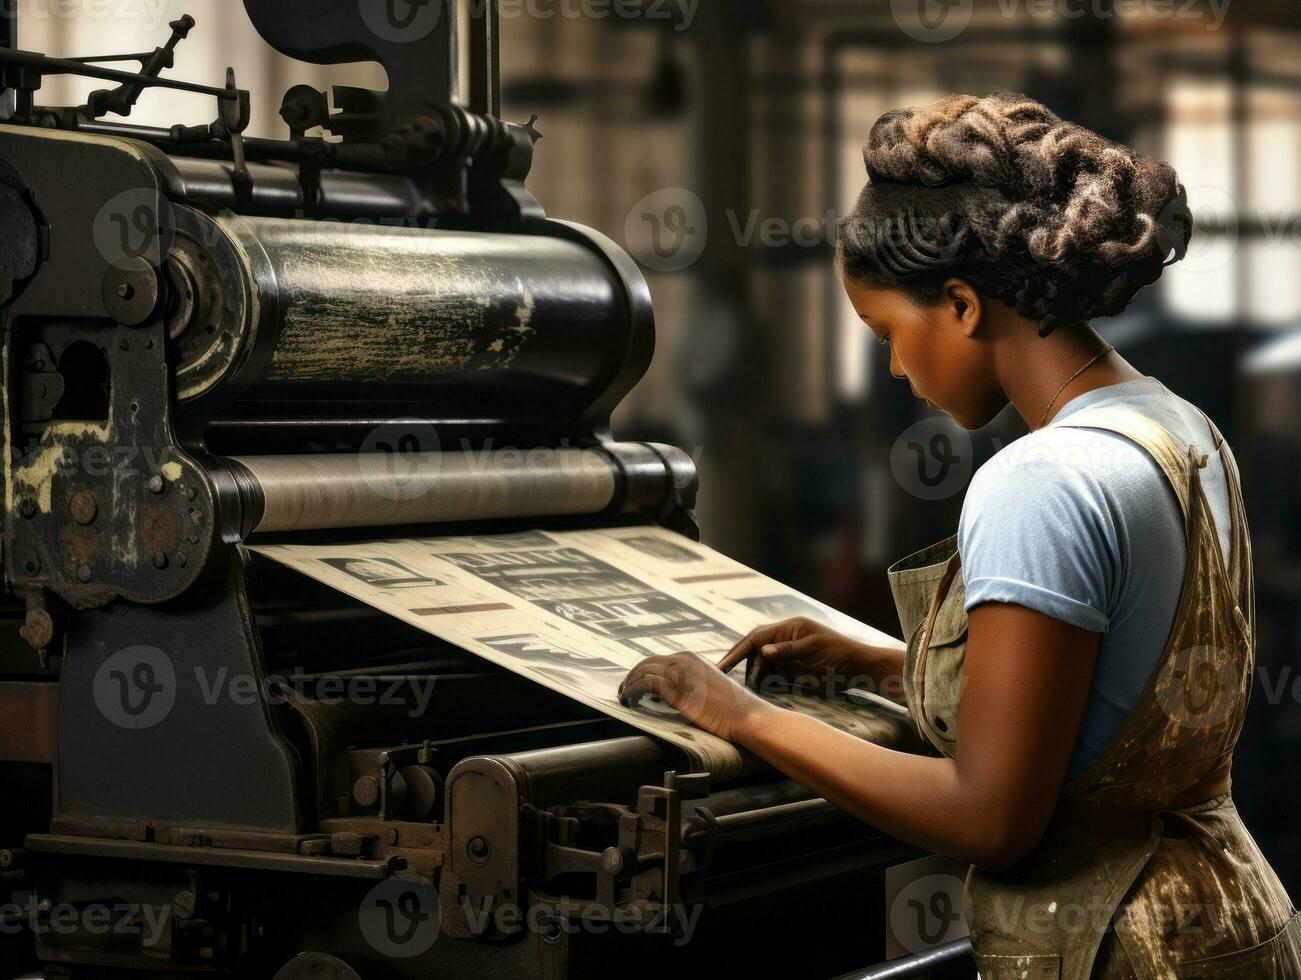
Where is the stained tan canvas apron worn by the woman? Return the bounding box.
[890,407,1301,980]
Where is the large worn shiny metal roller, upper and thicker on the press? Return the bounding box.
[175,204,653,426]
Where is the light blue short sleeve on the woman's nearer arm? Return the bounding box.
[958,429,1119,633]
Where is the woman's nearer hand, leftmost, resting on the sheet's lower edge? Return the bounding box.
[619,652,771,742]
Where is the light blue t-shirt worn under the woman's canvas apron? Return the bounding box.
[958,377,1232,778]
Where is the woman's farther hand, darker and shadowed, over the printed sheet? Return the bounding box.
[718,617,903,694]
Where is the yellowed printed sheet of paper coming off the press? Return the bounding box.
[251,527,909,778]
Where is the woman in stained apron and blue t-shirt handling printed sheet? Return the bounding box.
[622,94,1301,980]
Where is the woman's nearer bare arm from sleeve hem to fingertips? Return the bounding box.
[624,603,1099,868]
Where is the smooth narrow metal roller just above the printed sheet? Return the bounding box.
[228,449,619,532]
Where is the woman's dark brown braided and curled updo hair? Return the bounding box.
[838,92,1193,336]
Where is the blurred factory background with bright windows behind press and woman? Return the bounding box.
[17,0,1301,895]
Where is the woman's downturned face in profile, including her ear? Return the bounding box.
[840,276,1007,429]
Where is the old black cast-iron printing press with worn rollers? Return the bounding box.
[0,0,957,980]
